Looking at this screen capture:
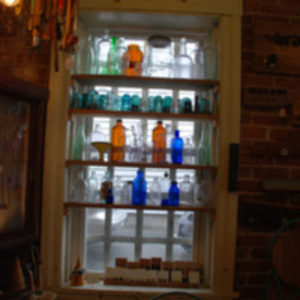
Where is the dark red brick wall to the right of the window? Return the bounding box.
[235,0,300,300]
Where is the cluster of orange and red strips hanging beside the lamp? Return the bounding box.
[0,0,78,70]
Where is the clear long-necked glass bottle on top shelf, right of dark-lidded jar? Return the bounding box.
[174,37,193,78]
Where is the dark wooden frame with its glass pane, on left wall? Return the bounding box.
[0,74,48,248]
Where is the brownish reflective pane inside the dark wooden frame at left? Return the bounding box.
[0,99,30,234]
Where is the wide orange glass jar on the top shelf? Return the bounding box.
[123,44,143,76]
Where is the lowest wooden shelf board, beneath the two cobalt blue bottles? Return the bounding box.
[64,202,215,212]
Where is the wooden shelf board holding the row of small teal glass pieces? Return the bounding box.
[69,109,218,122]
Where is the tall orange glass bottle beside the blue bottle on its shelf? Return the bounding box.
[152,121,166,163]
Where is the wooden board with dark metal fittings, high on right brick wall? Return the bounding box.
[254,22,300,76]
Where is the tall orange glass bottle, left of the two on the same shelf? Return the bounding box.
[110,120,126,161]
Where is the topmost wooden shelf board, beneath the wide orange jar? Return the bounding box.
[72,74,219,90]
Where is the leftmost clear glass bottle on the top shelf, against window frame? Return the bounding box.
[76,33,94,74]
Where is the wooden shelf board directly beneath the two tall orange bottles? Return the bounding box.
[66,160,217,172]
